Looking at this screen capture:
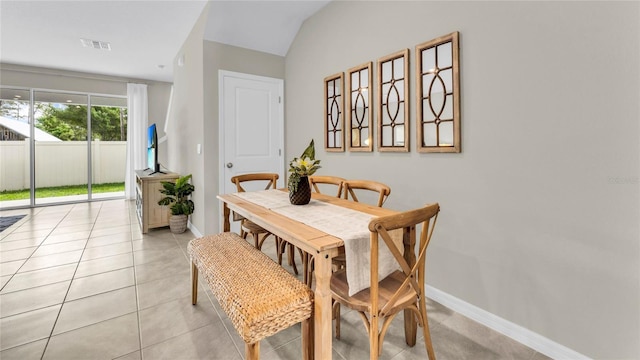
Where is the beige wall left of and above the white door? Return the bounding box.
[167,8,284,235]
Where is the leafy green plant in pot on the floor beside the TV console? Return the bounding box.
[158,174,195,234]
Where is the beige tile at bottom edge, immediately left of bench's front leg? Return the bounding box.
[142,323,244,360]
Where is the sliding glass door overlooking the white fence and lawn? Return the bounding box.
[0,88,127,208]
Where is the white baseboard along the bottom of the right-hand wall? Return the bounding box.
[425,285,589,360]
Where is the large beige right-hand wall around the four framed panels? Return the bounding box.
[285,1,640,359]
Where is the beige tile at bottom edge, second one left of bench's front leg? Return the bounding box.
[43,313,140,360]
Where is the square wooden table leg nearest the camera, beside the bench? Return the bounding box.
[313,251,332,360]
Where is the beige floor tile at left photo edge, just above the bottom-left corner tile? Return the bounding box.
[0,305,61,350]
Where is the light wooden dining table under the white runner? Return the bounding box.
[218,190,400,359]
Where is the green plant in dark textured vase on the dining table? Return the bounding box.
[287,139,321,205]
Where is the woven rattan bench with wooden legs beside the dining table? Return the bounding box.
[187,233,313,359]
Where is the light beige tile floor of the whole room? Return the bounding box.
[0,200,547,360]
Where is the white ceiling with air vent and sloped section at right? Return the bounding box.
[0,0,330,82]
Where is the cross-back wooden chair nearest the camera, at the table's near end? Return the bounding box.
[331,203,440,360]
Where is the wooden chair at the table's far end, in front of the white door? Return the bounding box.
[231,173,290,268]
